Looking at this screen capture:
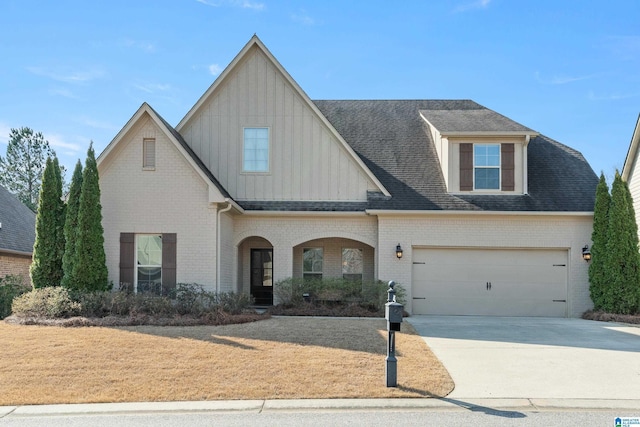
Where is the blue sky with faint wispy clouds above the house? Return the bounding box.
[0,0,640,182]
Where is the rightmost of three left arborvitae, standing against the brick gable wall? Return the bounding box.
[73,144,109,291]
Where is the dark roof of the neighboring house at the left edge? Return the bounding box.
[0,186,36,255]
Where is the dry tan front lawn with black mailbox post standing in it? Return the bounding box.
[0,317,453,405]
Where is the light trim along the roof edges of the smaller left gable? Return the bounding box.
[96,102,229,203]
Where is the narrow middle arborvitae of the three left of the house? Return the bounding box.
[62,160,82,288]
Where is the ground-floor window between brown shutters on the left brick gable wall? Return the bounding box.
[135,234,162,295]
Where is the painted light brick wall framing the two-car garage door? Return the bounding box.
[378,214,593,317]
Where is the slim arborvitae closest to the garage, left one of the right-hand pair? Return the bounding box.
[589,173,611,310]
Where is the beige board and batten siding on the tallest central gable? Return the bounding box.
[178,47,377,201]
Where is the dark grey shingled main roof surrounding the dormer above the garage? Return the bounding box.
[314,100,598,212]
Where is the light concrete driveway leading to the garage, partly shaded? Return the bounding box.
[408,316,640,399]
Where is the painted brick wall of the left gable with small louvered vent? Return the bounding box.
[99,116,216,290]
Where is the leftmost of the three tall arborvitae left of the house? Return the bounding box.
[30,157,63,288]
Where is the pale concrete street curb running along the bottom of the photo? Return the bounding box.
[0,398,640,419]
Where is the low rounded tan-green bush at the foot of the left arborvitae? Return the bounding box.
[11,286,82,319]
